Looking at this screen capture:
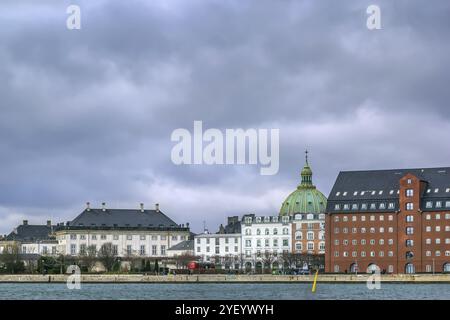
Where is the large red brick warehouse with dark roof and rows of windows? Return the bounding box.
[325,168,450,273]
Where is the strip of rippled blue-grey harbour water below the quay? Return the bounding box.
[0,283,450,300]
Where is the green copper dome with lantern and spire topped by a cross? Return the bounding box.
[280,151,327,216]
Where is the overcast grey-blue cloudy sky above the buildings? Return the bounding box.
[0,0,450,234]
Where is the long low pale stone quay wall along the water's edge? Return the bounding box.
[0,274,450,284]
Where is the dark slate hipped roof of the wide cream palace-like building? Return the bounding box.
[65,209,179,228]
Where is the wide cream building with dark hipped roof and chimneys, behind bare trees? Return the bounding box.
[56,203,190,258]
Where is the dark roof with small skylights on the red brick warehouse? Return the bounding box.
[327,167,450,212]
